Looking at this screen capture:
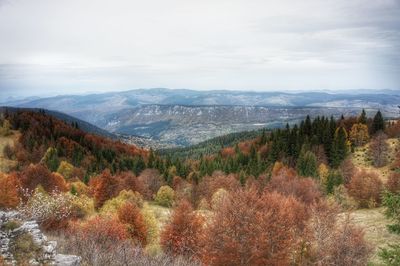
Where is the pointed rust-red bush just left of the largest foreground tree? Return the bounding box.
[160,200,204,257]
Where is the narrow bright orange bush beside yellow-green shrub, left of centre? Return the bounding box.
[118,202,147,246]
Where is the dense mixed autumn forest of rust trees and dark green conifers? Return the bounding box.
[0,110,400,265]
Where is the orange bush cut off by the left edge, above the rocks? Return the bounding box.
[0,173,21,208]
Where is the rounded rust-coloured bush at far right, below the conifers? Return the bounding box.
[347,170,382,208]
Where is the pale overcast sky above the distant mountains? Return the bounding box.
[0,0,400,99]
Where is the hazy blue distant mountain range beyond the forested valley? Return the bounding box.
[6,89,400,146]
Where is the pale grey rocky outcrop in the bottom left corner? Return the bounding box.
[0,211,81,266]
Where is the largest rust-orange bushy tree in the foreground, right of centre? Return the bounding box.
[201,189,307,265]
